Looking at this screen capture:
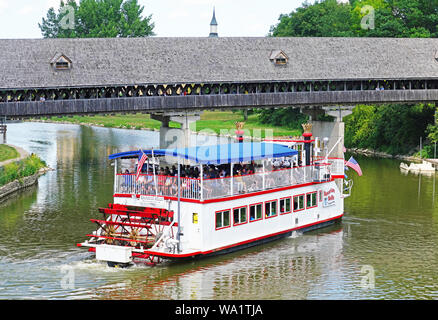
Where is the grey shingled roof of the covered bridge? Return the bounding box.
[0,37,438,89]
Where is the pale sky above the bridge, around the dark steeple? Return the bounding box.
[0,0,313,39]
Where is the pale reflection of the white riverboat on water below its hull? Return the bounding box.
[83,225,353,300]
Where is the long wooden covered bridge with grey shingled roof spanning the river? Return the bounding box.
[0,37,438,150]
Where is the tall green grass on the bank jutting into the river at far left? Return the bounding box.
[0,153,47,187]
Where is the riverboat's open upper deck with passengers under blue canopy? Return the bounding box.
[109,143,344,201]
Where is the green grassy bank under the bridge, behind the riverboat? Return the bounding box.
[42,111,301,137]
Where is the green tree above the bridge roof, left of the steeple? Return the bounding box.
[38,0,155,38]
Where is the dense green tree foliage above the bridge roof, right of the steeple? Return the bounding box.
[270,0,438,38]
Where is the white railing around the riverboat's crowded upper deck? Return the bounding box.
[114,163,331,200]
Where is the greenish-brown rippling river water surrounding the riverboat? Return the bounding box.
[0,123,438,300]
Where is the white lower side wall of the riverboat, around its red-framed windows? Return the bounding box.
[109,180,344,259]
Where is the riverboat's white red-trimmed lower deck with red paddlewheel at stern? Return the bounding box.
[80,180,344,264]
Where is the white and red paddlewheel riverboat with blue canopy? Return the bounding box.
[78,129,351,266]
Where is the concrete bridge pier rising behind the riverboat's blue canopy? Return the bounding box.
[151,112,201,149]
